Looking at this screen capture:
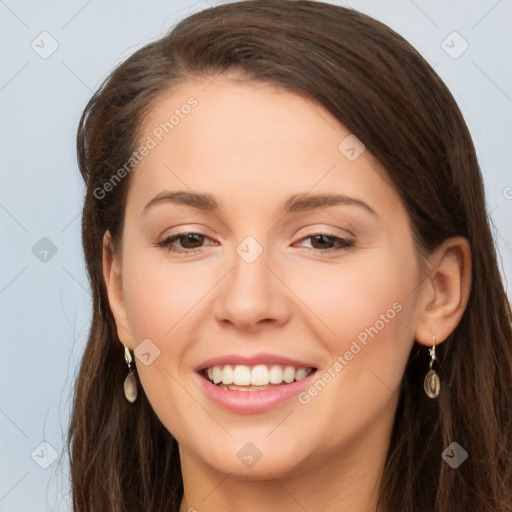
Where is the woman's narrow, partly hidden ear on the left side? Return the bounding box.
[102,231,133,350]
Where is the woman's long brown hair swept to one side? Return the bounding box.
[69,0,512,512]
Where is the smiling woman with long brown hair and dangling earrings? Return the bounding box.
[69,0,512,512]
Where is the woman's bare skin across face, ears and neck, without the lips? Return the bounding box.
[104,76,470,512]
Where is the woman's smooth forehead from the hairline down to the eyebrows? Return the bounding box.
[126,77,402,220]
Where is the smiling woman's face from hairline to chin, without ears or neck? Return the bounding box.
[111,77,421,478]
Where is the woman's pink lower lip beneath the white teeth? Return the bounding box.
[196,371,316,414]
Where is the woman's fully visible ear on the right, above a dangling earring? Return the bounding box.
[415,237,471,346]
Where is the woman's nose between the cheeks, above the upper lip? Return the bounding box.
[214,244,291,331]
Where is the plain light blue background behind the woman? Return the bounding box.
[0,0,512,512]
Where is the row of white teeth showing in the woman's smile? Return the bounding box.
[206,364,313,390]
